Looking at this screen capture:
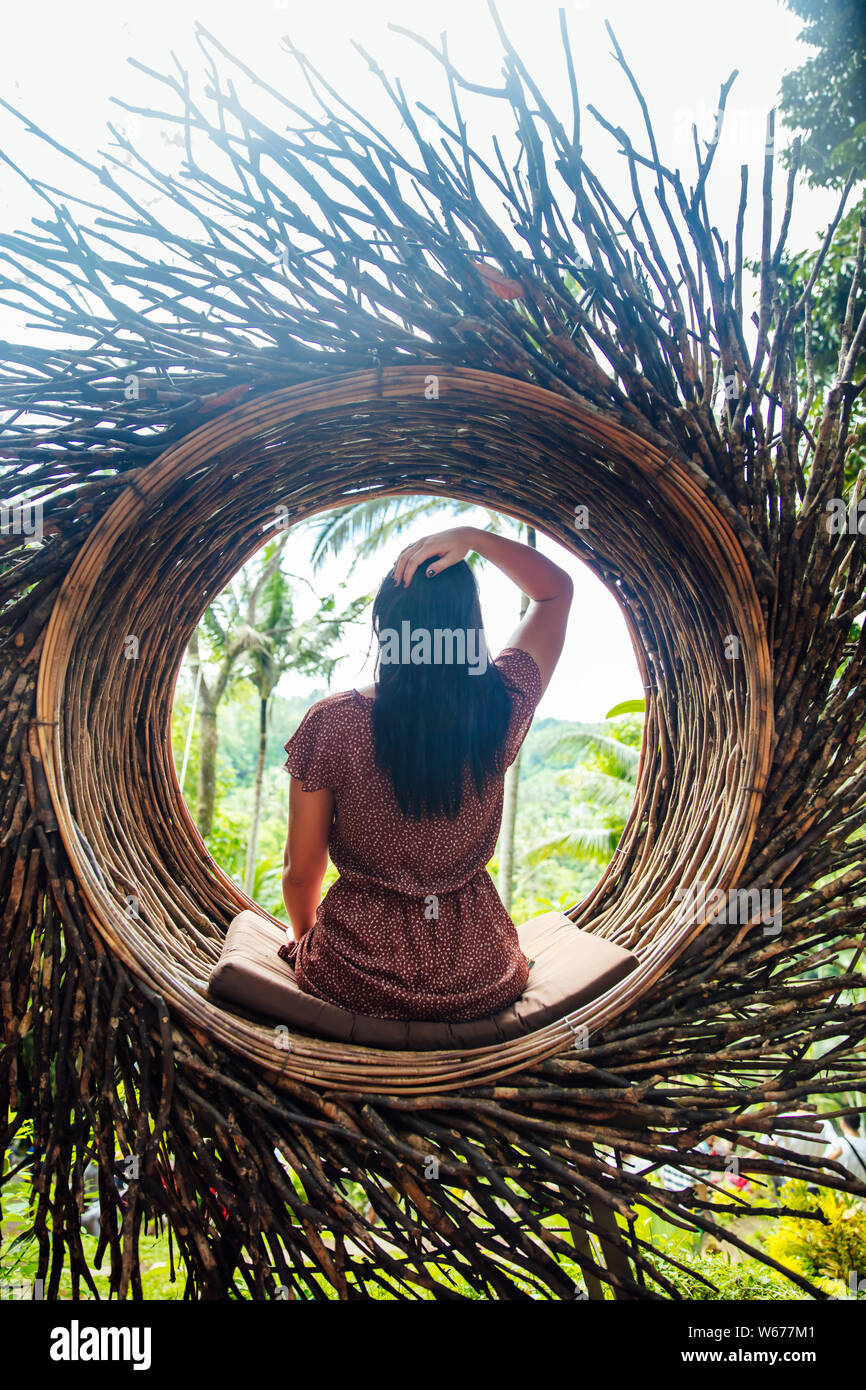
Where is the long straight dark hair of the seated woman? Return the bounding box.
[373,560,512,820]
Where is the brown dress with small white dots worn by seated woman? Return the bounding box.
[279,646,541,1022]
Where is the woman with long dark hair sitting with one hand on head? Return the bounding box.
[279,527,573,1022]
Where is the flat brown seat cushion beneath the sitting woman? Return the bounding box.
[210,910,638,1049]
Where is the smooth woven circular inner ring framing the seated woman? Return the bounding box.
[38,364,771,1094]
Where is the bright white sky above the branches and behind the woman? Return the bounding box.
[0,0,835,720]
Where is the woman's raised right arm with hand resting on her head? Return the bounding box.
[393,525,574,691]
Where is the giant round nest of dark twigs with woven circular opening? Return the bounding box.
[0,21,866,1298]
